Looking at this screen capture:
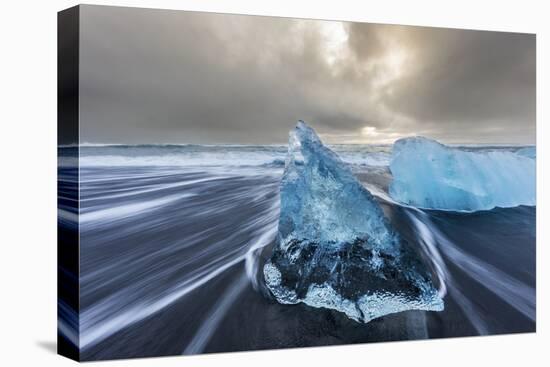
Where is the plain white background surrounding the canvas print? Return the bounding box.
[0,0,550,367]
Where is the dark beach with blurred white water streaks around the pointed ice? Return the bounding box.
[66,167,535,360]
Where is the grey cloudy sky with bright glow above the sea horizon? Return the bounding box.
[80,6,536,144]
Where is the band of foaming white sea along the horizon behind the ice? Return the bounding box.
[58,143,534,173]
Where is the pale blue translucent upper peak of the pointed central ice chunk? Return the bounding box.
[279,120,393,250]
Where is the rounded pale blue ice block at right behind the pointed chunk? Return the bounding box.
[389,137,536,211]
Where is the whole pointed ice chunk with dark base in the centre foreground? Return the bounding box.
[263,121,444,322]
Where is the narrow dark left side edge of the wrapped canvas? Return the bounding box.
[57,6,79,360]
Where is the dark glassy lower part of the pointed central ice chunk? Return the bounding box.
[264,234,443,322]
